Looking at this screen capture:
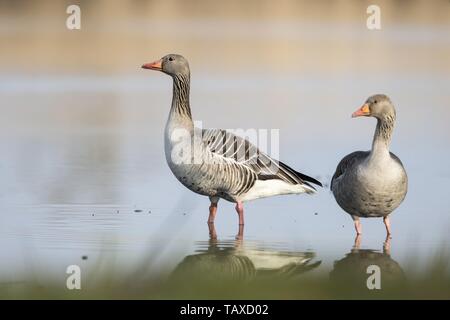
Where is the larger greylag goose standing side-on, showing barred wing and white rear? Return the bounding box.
[142,54,321,224]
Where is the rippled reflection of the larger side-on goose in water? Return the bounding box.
[172,224,321,281]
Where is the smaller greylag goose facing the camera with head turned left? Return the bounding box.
[331,94,408,236]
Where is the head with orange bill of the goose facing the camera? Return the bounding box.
[352,94,395,120]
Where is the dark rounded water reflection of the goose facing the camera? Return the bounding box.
[330,235,405,291]
